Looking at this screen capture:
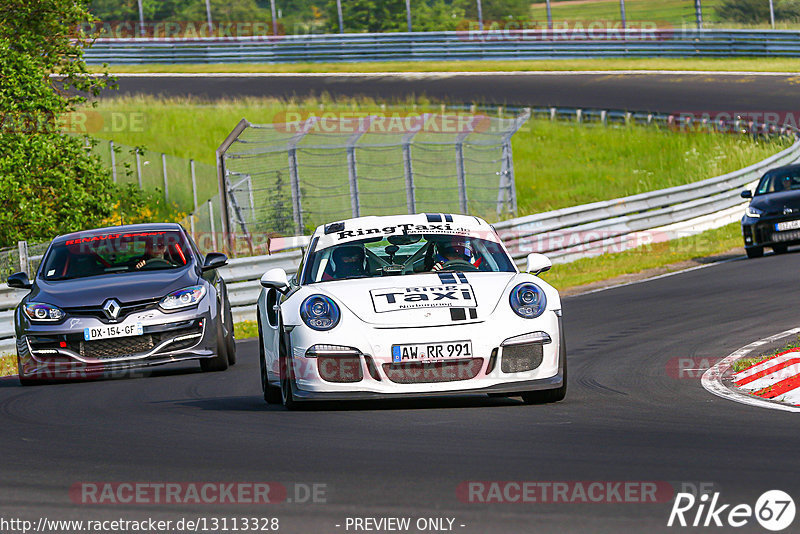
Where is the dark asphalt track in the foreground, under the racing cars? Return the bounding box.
[0,253,800,534]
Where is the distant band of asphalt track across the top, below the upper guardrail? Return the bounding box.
[104,72,800,113]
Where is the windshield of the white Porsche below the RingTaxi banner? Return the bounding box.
[304,234,515,284]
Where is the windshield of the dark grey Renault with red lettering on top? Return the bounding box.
[41,231,191,280]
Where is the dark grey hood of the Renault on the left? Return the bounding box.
[28,265,198,308]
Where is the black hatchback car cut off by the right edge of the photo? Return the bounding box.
[742,165,800,258]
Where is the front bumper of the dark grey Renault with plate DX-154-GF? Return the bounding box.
[17,308,216,379]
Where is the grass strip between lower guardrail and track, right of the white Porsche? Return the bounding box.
[542,223,742,291]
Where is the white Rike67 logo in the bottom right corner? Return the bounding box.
[667,490,795,532]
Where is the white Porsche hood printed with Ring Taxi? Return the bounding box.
[309,272,517,328]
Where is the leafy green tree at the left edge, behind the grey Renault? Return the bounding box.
[0,0,116,246]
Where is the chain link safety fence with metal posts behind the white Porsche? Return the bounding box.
[196,109,530,253]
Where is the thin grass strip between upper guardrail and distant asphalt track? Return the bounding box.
[92,58,800,74]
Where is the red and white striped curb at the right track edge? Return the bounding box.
[701,328,800,412]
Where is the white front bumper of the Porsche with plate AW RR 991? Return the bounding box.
[290,311,566,401]
